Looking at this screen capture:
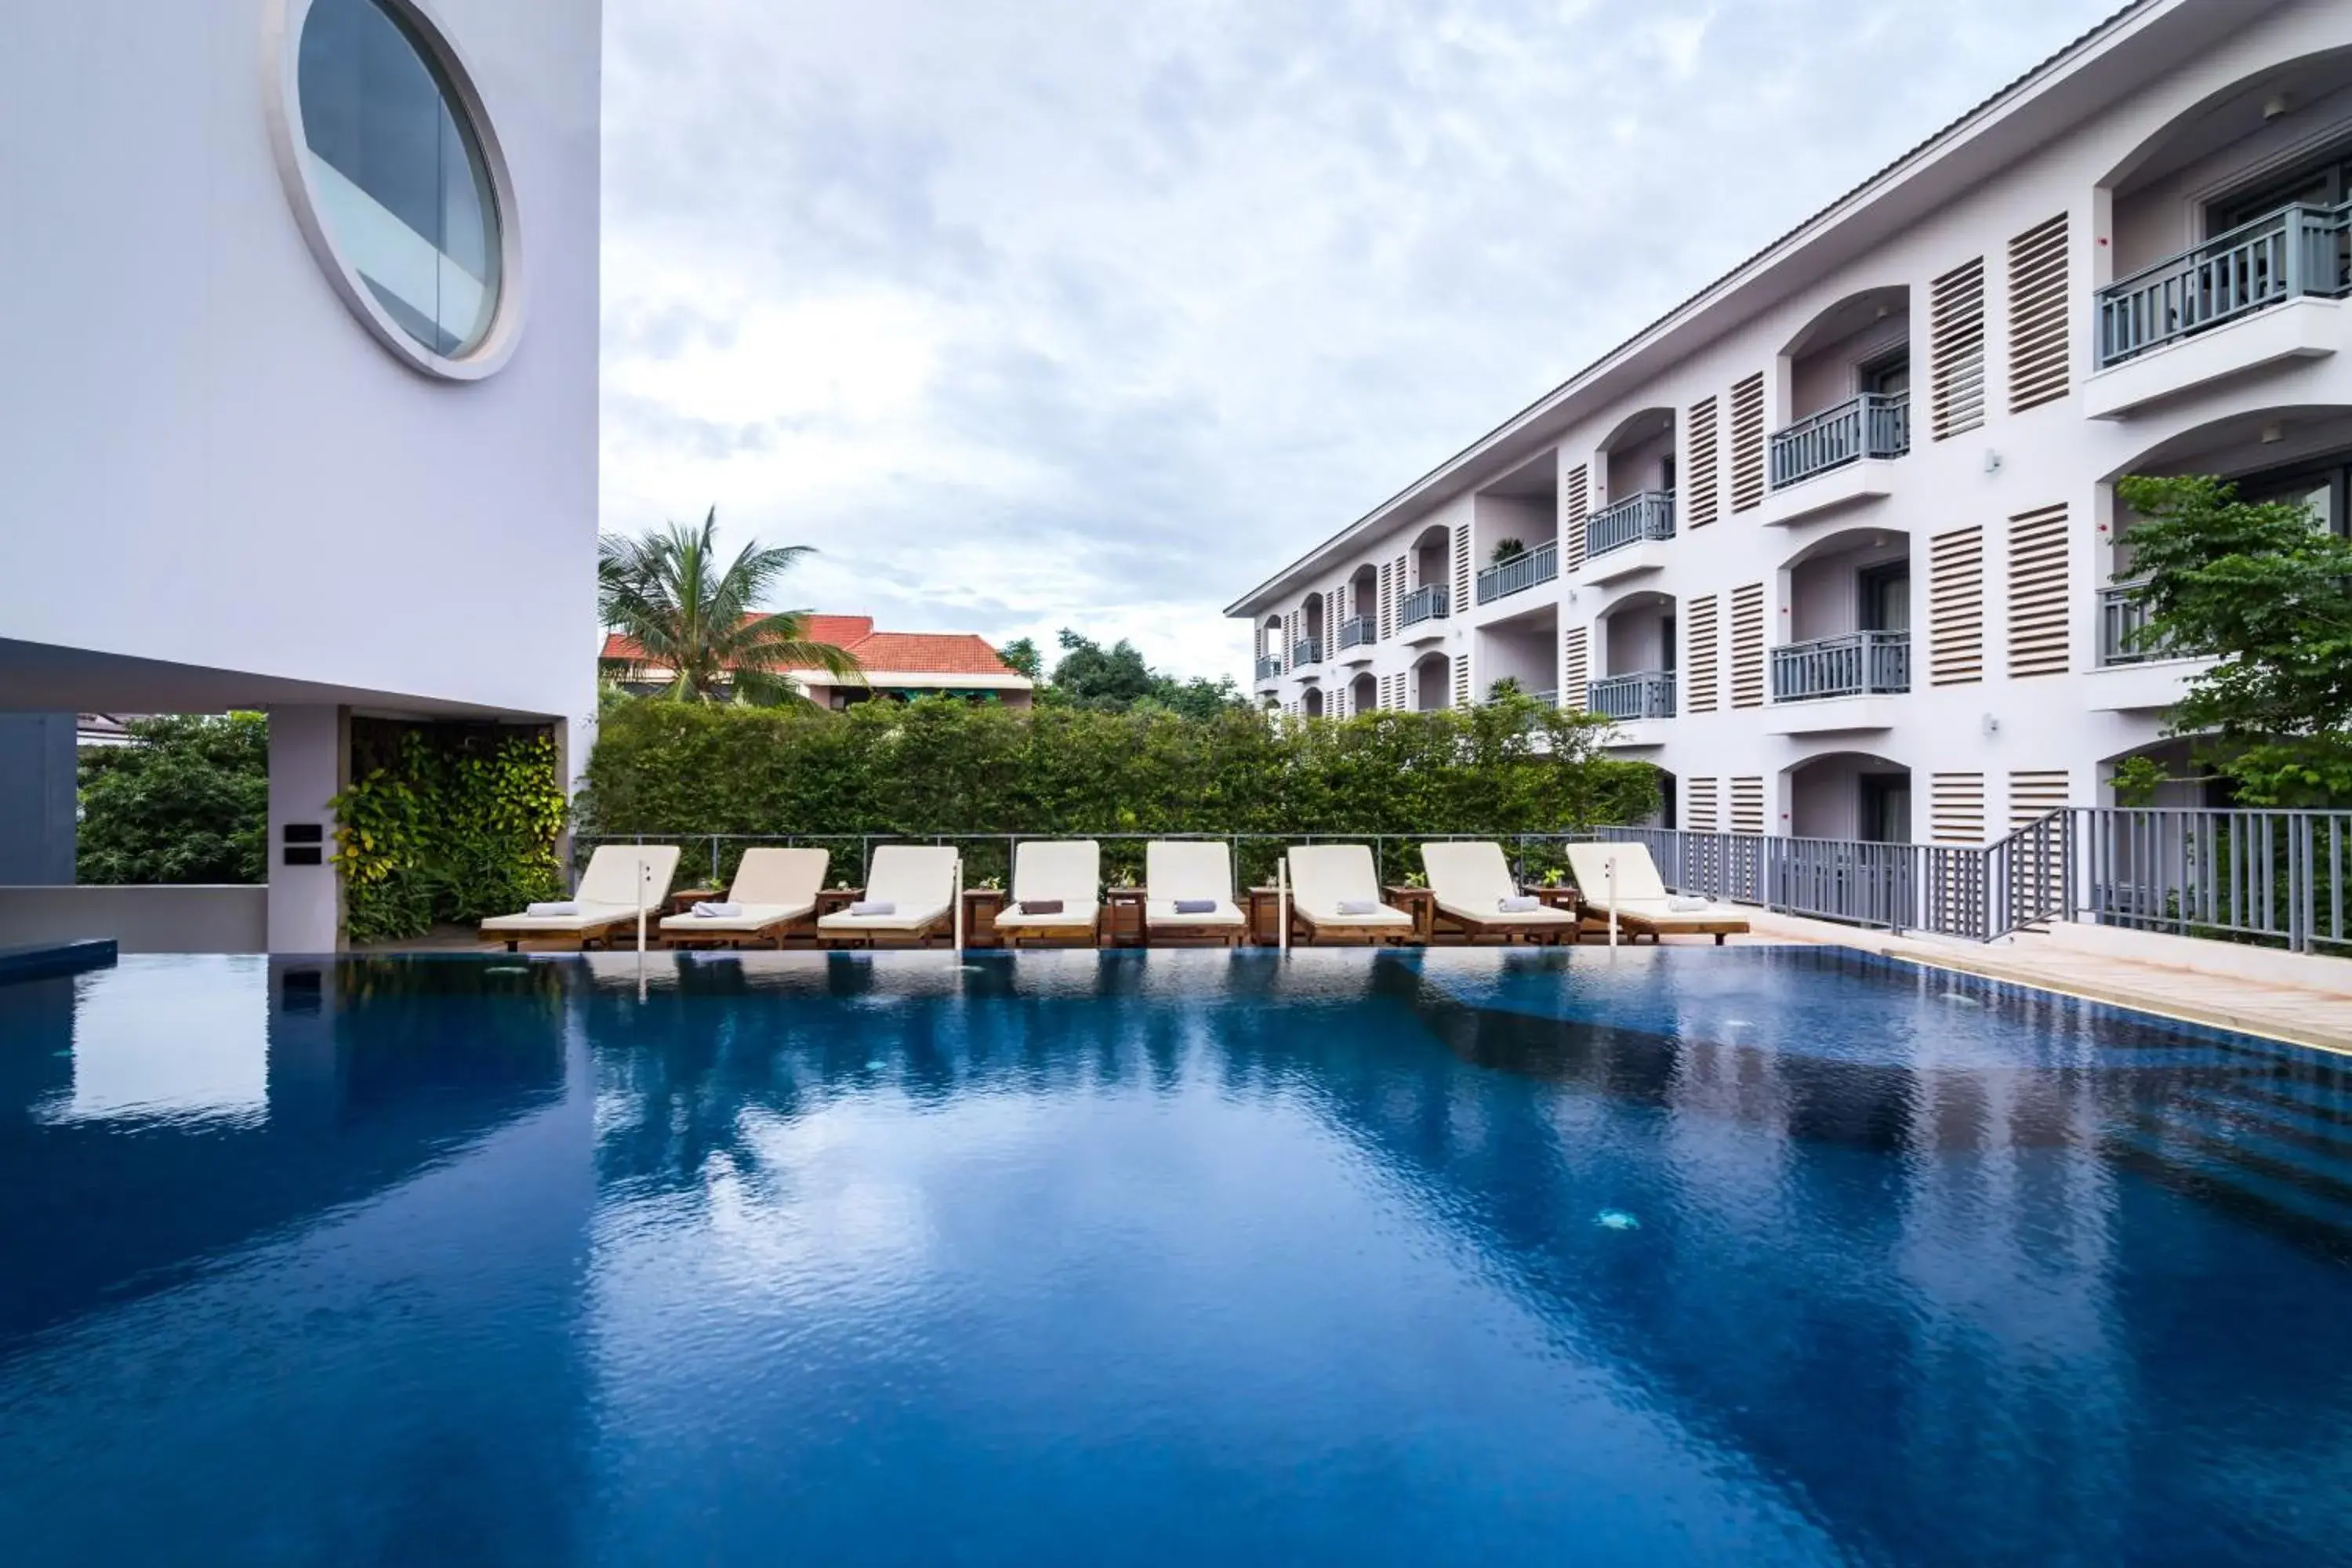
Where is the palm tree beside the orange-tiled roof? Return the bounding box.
[597,508,863,703]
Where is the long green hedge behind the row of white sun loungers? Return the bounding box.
[579,699,1658,877]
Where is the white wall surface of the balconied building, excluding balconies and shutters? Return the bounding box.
[1232,0,2352,839]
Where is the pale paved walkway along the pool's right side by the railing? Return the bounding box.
[1757,914,2352,1053]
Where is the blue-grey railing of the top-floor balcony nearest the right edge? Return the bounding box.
[2098,202,2352,369]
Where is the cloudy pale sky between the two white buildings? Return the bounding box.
[604,0,2117,677]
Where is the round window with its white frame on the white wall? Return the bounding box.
[280,0,513,379]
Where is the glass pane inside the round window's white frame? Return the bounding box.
[299,0,499,360]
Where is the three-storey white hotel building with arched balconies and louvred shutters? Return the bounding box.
[1228,0,2352,844]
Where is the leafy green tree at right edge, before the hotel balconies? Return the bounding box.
[2114,475,2352,806]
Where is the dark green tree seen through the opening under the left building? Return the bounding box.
[75,713,270,884]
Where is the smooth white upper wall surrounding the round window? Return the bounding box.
[0,0,602,733]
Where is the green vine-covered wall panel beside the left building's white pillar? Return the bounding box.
[334,720,567,942]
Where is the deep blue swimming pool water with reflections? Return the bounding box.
[0,947,2352,1568]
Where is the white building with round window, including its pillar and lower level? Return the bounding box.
[0,0,602,952]
